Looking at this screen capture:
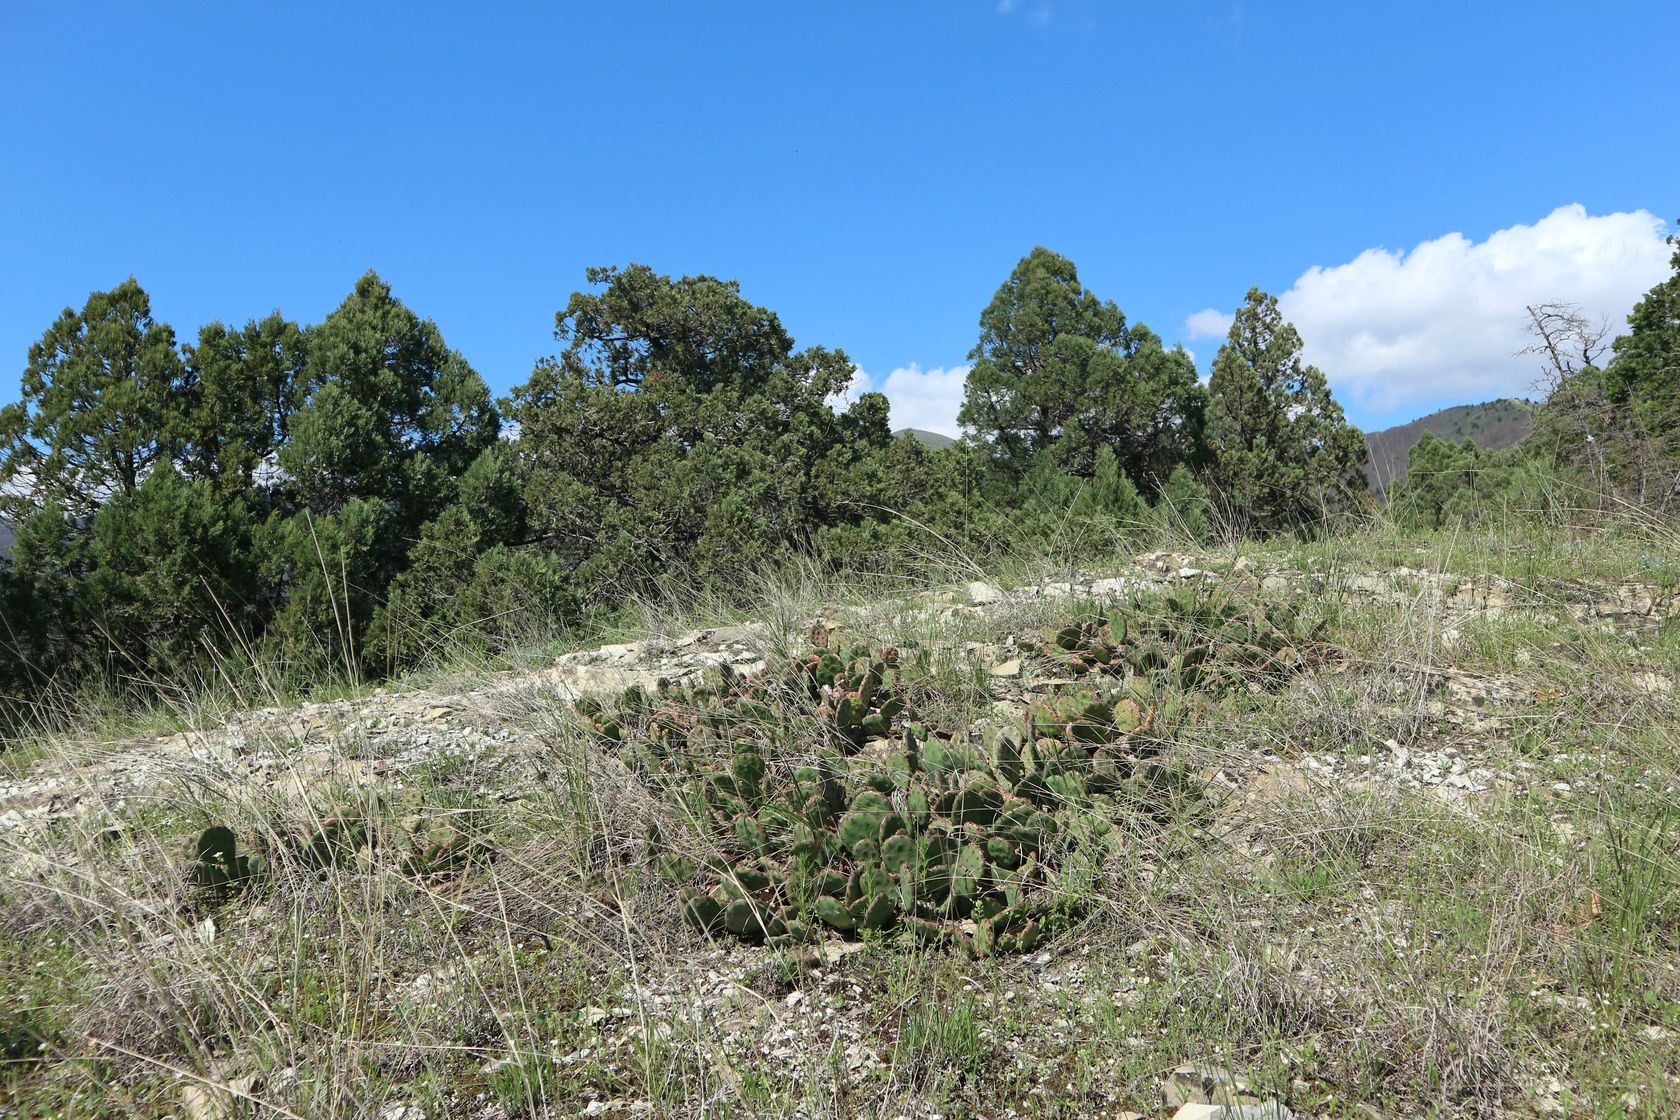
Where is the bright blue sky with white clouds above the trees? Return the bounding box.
[0,0,1680,427]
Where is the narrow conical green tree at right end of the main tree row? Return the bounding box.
[1206,289,1366,531]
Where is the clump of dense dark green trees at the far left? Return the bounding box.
[0,272,517,709]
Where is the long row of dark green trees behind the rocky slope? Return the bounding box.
[0,249,1512,728]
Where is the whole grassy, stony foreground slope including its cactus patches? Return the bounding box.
[0,534,1680,1120]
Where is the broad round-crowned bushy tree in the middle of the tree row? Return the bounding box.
[511,265,894,594]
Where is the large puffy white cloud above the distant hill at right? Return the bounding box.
[1263,203,1672,413]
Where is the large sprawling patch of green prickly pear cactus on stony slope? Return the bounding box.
[591,620,1236,954]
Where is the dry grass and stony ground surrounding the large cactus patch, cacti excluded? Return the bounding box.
[0,527,1680,1120]
